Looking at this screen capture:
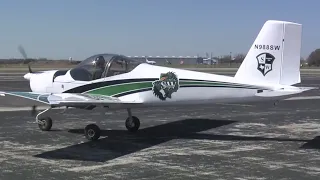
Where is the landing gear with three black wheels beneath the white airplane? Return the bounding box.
[36,108,140,141]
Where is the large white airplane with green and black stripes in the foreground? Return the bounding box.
[0,20,315,140]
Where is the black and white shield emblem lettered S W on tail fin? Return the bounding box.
[256,53,275,76]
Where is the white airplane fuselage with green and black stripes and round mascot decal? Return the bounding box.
[26,63,302,106]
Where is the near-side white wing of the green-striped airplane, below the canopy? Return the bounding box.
[0,91,141,107]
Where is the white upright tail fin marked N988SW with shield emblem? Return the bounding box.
[235,20,302,85]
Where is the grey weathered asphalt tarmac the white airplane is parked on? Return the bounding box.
[0,72,320,180]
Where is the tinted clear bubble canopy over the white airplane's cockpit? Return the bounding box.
[70,54,142,81]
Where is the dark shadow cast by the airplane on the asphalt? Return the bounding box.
[35,119,320,162]
